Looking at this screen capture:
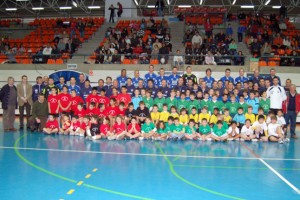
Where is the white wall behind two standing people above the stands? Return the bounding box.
[105,0,137,22]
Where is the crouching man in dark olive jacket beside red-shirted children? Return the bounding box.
[29,94,48,132]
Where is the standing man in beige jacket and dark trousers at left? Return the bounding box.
[17,75,32,129]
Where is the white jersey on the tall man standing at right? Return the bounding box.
[267,85,286,109]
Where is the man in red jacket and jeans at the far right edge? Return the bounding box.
[283,84,300,139]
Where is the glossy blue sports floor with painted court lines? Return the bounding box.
[0,121,300,200]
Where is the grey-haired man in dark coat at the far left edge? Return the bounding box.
[0,76,17,131]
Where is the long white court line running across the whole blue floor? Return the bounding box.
[0,146,300,161]
